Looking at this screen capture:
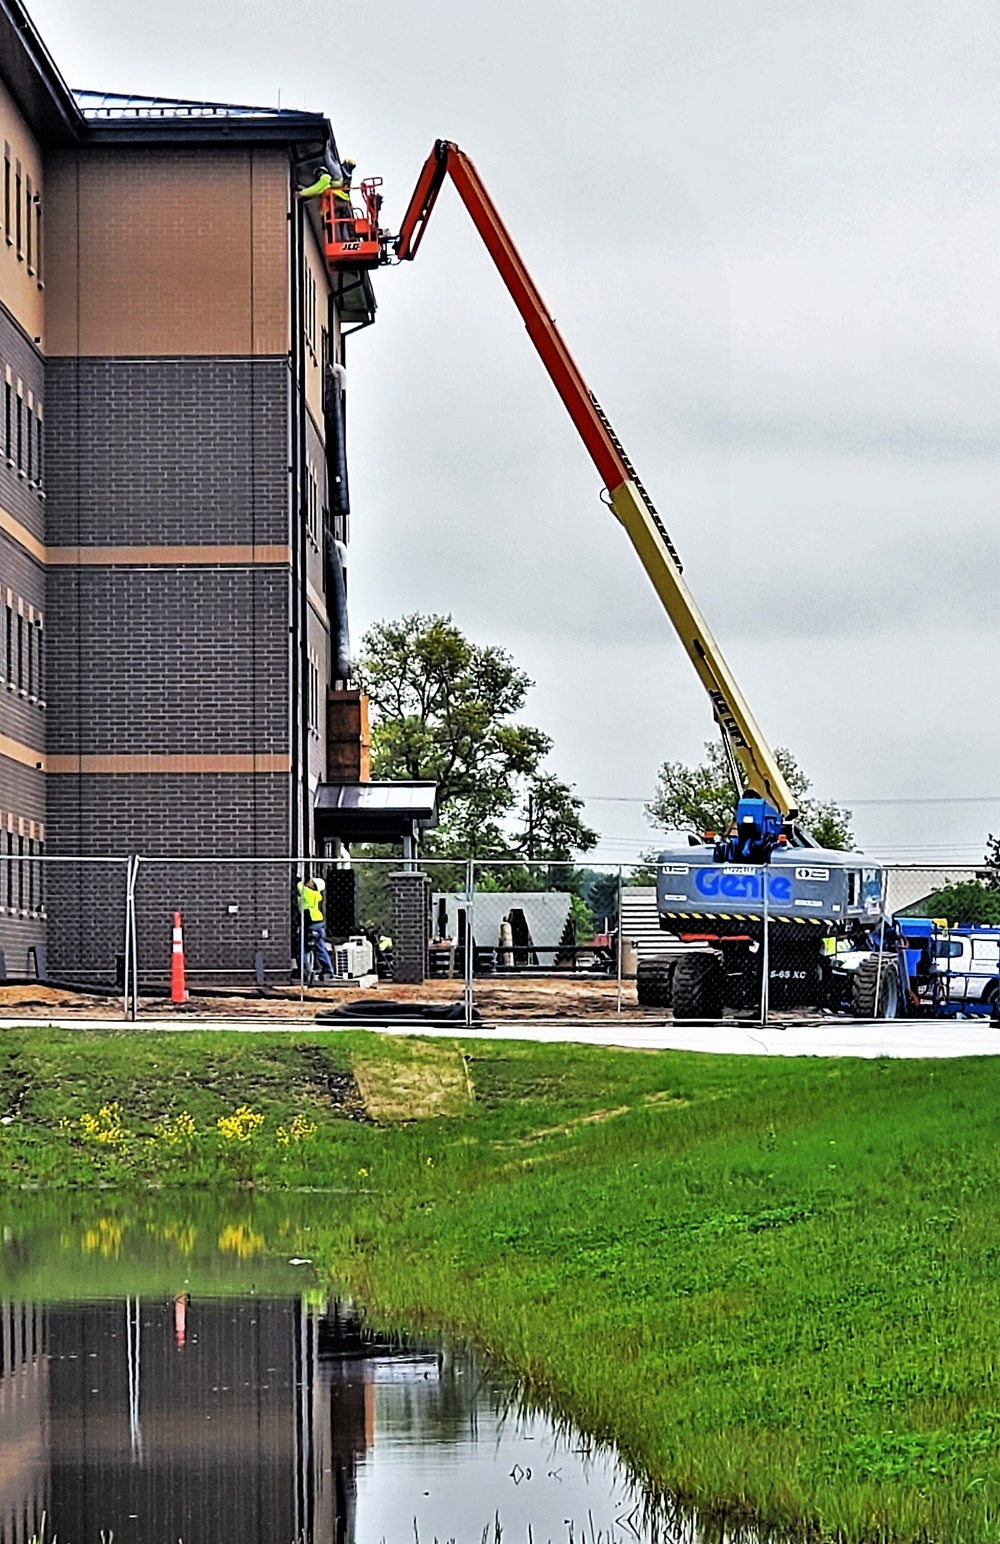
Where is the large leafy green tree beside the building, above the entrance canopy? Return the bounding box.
[356,613,597,864]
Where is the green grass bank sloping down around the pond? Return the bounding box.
[0,1031,1000,1544]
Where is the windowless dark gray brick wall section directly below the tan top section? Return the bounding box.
[46,355,290,547]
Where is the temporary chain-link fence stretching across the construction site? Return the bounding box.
[0,848,1000,1028]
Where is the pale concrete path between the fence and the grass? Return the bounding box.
[0,1014,1000,1058]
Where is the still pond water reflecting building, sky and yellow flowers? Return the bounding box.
[0,1200,675,1544]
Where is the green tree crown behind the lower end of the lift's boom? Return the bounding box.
[647,740,853,852]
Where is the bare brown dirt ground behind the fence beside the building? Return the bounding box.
[0,976,641,1021]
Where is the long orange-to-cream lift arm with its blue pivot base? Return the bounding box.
[392,139,809,863]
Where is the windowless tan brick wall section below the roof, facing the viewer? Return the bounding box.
[46,147,289,357]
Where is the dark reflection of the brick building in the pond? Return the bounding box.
[0,1299,453,1544]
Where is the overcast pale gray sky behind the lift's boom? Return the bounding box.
[31,0,1000,857]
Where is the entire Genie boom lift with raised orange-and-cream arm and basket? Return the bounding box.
[326,139,906,1019]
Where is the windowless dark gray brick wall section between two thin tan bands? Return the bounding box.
[46,567,289,759]
